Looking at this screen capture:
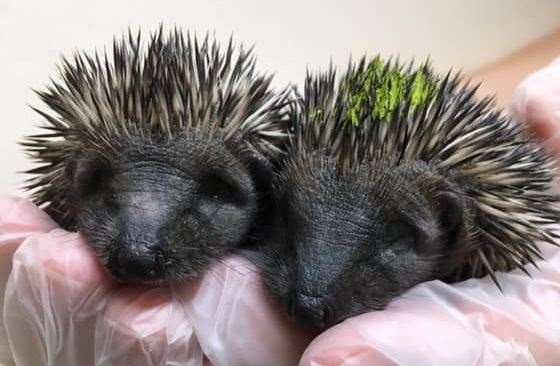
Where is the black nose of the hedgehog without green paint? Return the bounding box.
[113,249,160,282]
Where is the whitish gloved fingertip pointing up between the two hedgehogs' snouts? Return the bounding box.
[174,257,316,366]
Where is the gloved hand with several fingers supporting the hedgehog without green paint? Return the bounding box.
[0,198,307,366]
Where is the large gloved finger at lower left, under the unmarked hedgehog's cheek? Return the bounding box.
[3,229,109,365]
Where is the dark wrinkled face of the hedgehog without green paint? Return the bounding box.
[68,137,264,282]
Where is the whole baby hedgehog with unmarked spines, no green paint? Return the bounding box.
[22,27,288,283]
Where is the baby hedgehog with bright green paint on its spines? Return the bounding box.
[252,56,560,329]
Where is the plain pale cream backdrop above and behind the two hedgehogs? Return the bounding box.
[0,0,560,194]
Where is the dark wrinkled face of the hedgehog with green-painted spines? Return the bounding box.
[263,159,467,328]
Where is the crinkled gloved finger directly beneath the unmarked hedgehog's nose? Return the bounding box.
[96,286,204,366]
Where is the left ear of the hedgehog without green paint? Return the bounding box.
[65,152,111,198]
